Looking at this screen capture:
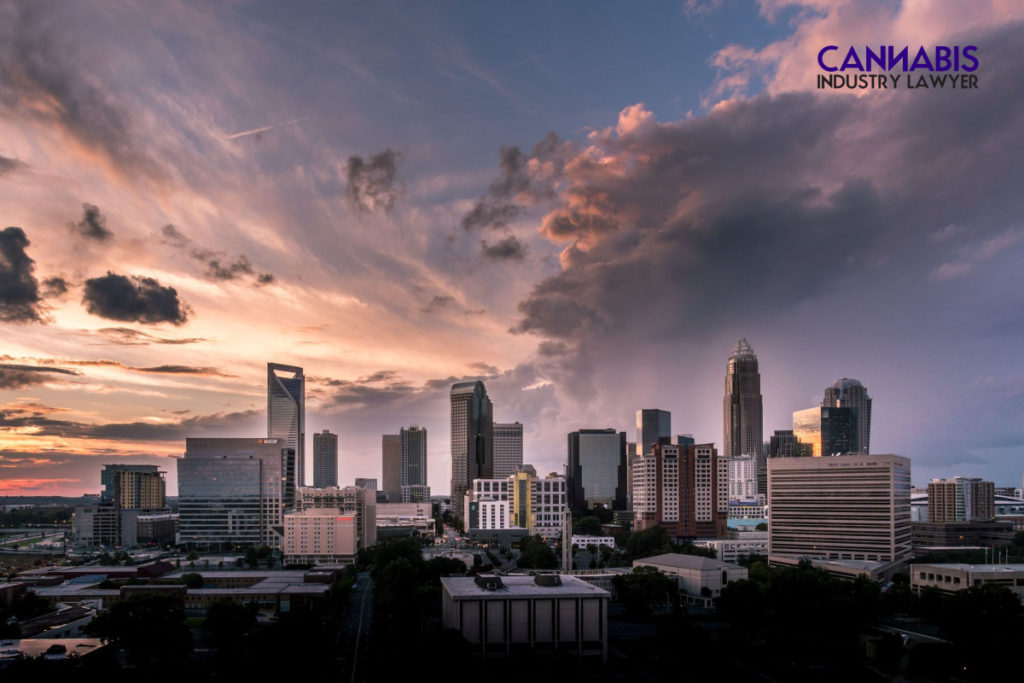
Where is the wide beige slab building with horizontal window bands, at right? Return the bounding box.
[768,455,911,562]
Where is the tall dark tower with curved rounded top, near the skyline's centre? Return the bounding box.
[451,381,495,514]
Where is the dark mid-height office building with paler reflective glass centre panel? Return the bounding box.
[566,428,627,511]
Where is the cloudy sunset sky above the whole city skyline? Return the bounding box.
[0,0,1024,496]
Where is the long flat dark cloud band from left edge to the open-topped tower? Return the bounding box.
[0,405,260,441]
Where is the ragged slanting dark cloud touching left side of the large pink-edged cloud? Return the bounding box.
[462,132,570,230]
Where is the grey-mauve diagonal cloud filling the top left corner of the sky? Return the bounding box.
[0,2,162,176]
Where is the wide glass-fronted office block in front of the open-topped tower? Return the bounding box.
[177,438,296,549]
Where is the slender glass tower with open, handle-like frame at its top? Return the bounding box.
[266,362,306,486]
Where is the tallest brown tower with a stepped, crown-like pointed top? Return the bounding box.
[722,339,767,494]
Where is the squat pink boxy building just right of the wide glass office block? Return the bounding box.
[283,508,358,564]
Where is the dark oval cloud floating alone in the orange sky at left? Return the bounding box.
[82,271,188,325]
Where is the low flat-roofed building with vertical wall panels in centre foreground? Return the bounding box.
[441,574,610,660]
